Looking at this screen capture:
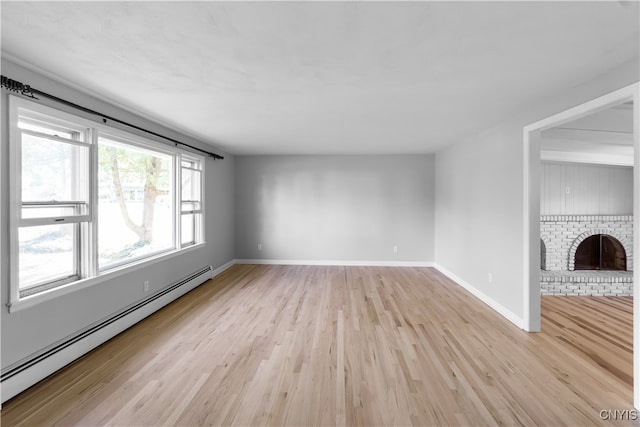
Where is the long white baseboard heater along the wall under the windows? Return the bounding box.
[0,266,213,402]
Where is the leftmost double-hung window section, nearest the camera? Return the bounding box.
[14,106,91,296]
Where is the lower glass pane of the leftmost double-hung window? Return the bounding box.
[18,224,77,289]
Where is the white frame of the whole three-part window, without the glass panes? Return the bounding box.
[8,95,206,312]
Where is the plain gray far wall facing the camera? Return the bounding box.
[235,155,435,262]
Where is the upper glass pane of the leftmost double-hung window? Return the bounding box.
[22,134,88,201]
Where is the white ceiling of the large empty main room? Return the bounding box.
[0,1,640,154]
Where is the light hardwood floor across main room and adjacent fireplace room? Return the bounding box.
[2,265,632,426]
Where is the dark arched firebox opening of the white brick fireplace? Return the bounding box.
[575,234,627,271]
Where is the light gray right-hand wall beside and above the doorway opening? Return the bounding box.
[435,57,639,324]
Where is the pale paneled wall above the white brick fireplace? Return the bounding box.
[540,162,633,215]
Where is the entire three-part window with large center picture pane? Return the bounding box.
[10,96,204,306]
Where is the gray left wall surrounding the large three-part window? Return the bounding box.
[0,60,234,368]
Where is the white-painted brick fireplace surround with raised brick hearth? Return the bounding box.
[540,215,633,295]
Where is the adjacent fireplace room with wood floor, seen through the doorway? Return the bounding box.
[540,102,634,402]
